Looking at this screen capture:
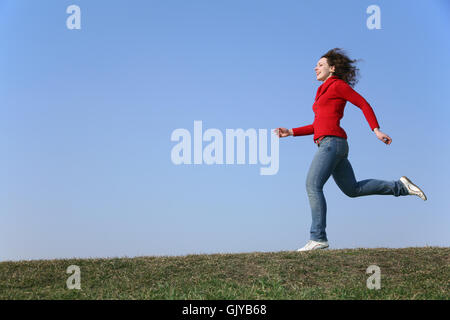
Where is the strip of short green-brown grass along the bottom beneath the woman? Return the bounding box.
[0,247,450,300]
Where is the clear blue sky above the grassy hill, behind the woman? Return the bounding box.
[0,0,450,260]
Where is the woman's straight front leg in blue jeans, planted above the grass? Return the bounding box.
[306,137,345,241]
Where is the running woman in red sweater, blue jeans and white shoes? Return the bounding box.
[275,48,427,251]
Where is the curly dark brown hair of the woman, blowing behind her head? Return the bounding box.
[322,48,359,87]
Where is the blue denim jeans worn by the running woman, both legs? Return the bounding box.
[306,136,408,241]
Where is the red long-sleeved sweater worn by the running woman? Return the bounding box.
[292,76,380,140]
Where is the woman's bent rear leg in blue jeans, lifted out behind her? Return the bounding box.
[332,158,408,198]
